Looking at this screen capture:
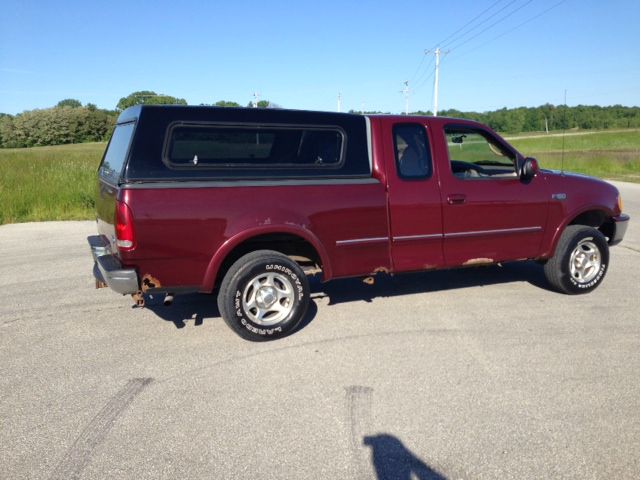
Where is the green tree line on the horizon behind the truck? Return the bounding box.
[0,90,640,148]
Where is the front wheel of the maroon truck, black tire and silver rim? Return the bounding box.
[544,225,609,295]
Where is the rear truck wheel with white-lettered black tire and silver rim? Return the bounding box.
[218,250,310,342]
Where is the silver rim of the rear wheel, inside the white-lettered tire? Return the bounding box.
[242,272,295,326]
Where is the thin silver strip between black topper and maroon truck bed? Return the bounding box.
[120,178,380,190]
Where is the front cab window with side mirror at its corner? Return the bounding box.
[444,126,517,180]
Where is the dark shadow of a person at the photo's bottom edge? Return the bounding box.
[362,433,447,480]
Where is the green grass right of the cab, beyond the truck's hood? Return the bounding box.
[508,129,640,182]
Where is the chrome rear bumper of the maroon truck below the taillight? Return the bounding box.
[87,235,140,295]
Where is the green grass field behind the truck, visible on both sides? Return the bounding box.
[0,130,640,224]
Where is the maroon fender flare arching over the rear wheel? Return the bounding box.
[202,224,333,292]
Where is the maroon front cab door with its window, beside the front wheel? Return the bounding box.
[439,124,548,266]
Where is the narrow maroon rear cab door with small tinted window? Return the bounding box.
[384,121,444,272]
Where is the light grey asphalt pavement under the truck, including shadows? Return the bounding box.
[0,183,640,480]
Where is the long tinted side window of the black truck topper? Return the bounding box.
[164,125,346,169]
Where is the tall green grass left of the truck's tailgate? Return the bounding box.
[0,143,106,224]
